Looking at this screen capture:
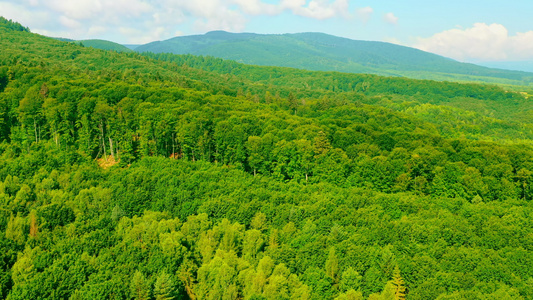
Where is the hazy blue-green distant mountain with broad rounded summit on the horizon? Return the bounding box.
[135,31,533,85]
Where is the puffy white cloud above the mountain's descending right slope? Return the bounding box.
[414,23,533,61]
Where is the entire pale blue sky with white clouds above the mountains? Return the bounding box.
[0,0,533,63]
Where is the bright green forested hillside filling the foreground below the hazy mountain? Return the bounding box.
[0,19,533,300]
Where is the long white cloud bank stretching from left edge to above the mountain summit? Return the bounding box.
[0,0,358,43]
